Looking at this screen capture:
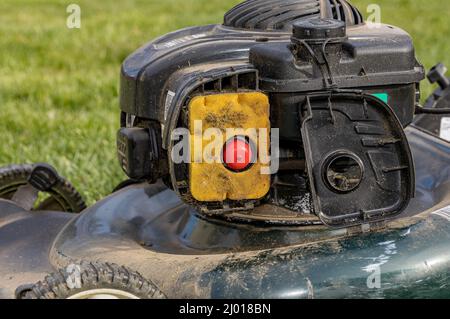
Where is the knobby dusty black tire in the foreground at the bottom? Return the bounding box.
[21,262,166,299]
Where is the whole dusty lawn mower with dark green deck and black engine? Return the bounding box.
[0,0,450,299]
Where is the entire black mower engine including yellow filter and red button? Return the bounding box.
[118,0,424,227]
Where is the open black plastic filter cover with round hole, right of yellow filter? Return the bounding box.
[302,94,414,226]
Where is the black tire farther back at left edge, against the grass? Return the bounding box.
[0,164,86,213]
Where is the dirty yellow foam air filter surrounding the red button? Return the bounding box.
[189,92,270,202]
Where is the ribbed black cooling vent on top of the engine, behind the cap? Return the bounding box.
[224,0,364,31]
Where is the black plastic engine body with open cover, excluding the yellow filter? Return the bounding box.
[119,0,424,227]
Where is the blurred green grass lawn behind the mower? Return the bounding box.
[0,0,450,204]
